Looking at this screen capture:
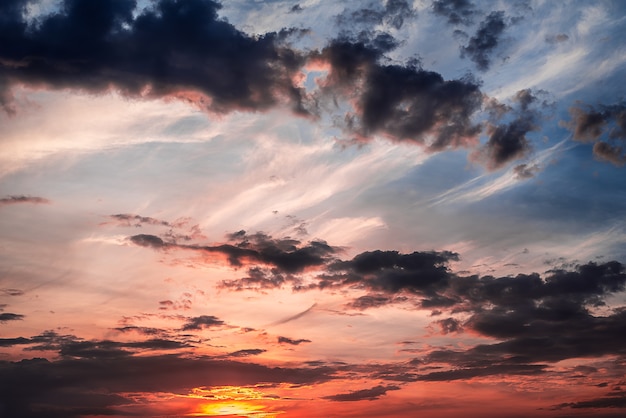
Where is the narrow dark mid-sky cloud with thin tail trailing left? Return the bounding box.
[129,231,338,272]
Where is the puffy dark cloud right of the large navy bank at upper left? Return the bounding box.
[313,39,482,151]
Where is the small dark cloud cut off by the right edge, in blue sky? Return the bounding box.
[561,103,626,166]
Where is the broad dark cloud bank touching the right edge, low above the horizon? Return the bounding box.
[408,262,626,372]
